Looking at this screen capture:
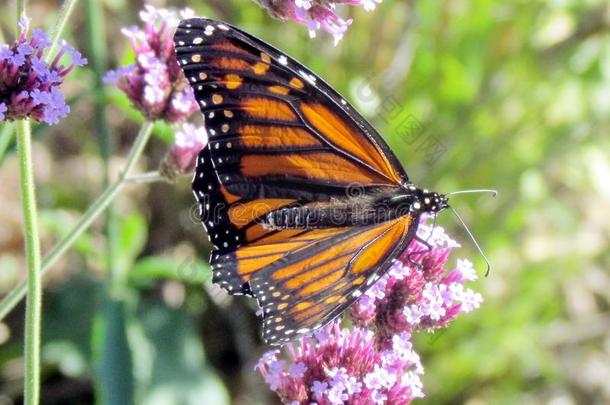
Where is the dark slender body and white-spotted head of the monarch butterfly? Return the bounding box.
[263,185,448,229]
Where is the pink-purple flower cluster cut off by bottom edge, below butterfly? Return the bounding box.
[256,322,423,405]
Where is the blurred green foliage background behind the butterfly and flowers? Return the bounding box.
[0,0,610,405]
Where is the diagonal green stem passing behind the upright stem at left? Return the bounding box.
[0,121,154,320]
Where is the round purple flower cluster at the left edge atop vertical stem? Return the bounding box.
[0,17,87,125]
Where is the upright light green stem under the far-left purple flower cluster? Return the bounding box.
[17,120,42,405]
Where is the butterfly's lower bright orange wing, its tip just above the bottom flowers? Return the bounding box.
[250,217,416,344]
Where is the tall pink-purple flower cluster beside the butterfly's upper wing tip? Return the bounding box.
[104,6,198,123]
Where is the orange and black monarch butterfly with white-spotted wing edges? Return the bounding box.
[174,18,448,345]
